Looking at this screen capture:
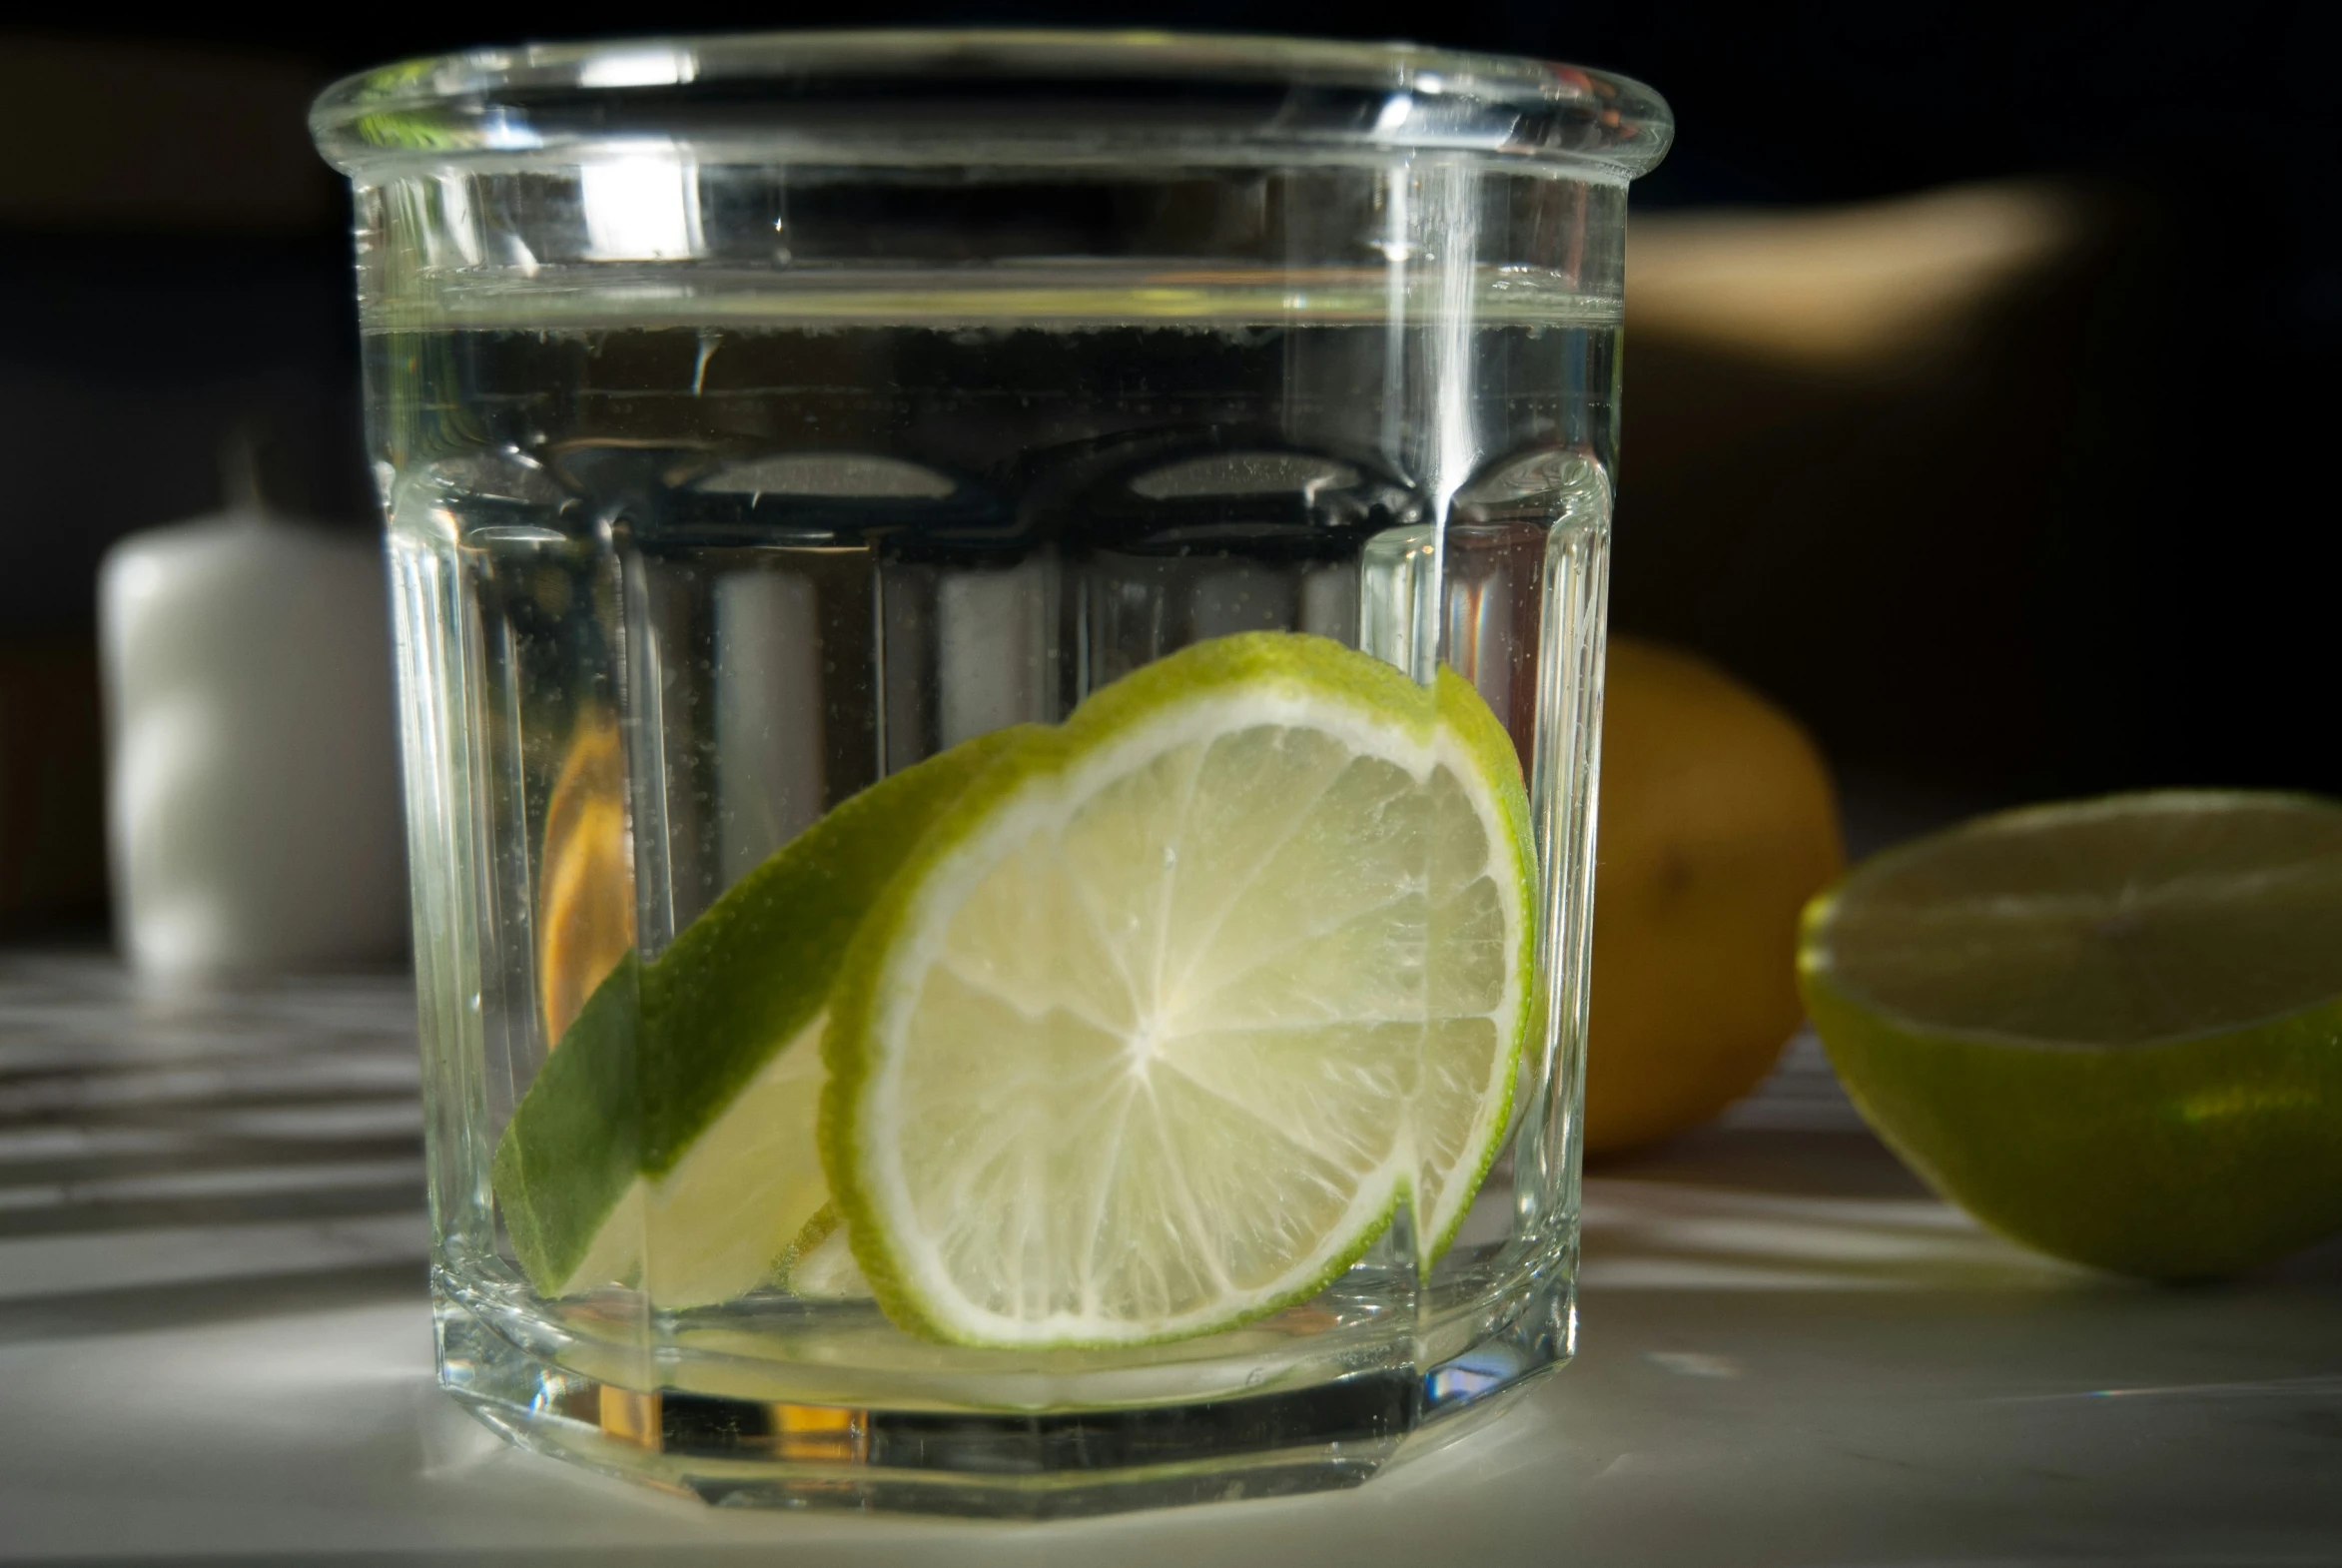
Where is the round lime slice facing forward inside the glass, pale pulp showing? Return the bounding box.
[822,632,1532,1345]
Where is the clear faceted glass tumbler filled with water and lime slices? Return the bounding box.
[314,33,1670,1514]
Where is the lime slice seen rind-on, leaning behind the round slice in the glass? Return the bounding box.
[494,728,1031,1308]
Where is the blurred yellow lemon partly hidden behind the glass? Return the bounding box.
[1586,636,1841,1154]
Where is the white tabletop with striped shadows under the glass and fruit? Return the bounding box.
[0,953,2342,1568]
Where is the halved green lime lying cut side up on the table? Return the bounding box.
[1799,791,2342,1277]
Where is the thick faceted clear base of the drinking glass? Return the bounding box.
[435,1275,1576,1519]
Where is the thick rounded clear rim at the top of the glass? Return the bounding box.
[310,28,1675,183]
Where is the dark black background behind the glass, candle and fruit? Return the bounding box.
[0,0,2342,927]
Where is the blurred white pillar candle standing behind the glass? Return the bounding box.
[98,507,407,976]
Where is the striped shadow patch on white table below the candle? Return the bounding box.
[0,950,428,1338]
